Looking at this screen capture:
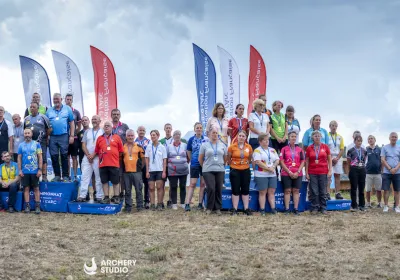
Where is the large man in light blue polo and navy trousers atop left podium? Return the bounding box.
[46,93,75,182]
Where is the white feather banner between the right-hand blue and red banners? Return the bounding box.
[218,47,240,119]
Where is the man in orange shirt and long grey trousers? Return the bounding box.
[123,129,145,213]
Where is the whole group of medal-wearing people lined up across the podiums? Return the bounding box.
[0,93,400,216]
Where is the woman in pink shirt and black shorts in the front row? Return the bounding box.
[280,131,305,215]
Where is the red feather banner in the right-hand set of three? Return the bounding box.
[247,45,267,115]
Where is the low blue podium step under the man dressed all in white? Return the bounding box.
[68,202,123,215]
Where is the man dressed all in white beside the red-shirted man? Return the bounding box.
[78,115,104,202]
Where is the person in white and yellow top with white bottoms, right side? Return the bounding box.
[326,121,344,200]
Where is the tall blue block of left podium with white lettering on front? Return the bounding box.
[25,182,79,213]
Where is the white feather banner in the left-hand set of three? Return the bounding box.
[51,50,85,116]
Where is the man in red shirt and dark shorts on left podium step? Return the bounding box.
[94,121,124,204]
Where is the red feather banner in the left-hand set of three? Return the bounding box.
[90,46,118,123]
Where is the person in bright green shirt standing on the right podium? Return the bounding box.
[270,101,288,154]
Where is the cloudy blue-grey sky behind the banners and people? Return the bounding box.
[0,0,400,144]
